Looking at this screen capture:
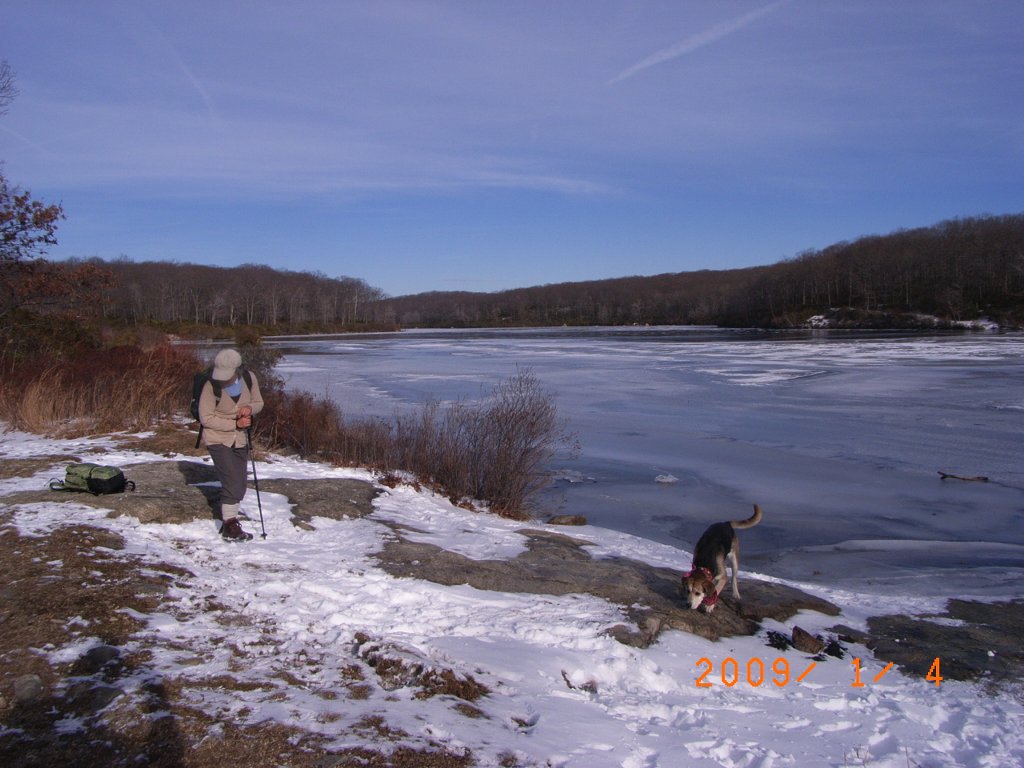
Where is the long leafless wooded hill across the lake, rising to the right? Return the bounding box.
[371,215,1024,327]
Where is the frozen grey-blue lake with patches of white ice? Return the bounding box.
[267,328,1024,596]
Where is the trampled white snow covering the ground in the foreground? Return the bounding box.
[0,432,1024,768]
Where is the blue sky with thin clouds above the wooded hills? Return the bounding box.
[0,0,1024,295]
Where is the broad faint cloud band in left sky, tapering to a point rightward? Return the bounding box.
[8,94,617,200]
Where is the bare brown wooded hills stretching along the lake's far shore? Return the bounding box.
[90,214,1024,333]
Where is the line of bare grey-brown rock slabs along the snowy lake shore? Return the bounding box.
[4,457,1024,684]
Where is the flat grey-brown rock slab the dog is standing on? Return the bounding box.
[377,528,840,647]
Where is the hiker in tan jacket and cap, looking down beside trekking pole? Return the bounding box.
[199,349,263,542]
